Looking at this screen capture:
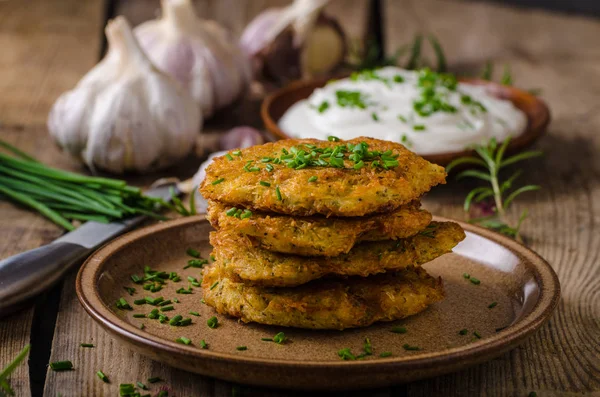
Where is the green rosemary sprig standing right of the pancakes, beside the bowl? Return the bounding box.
[446,138,542,241]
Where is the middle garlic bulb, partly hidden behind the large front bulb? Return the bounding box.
[134,0,251,118]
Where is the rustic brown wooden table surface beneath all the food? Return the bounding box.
[0,0,600,396]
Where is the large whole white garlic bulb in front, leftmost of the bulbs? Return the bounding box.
[48,17,202,173]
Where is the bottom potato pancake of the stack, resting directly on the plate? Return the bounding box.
[202,265,444,330]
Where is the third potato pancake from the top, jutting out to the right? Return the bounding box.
[210,222,465,287]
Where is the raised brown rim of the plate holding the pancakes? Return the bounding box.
[76,214,561,370]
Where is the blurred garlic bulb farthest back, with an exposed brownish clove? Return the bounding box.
[240,0,346,81]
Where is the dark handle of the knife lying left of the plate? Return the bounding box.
[0,242,91,315]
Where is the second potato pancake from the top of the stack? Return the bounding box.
[207,201,431,256]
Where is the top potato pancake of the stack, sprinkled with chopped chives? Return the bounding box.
[200,137,446,217]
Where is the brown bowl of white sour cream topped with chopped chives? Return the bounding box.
[261,67,550,165]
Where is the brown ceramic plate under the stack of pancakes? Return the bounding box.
[77,217,560,390]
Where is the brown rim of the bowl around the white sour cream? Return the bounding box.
[260,76,552,165]
